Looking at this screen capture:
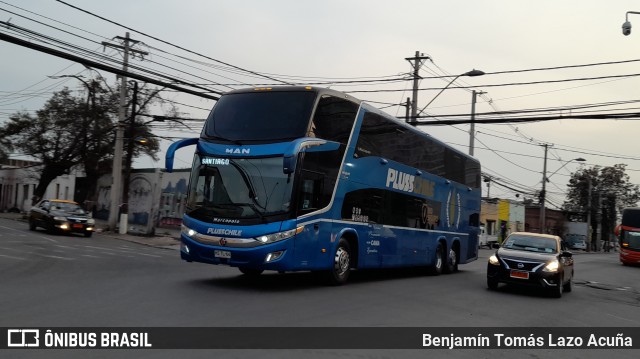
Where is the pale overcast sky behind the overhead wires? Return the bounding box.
[0,0,640,208]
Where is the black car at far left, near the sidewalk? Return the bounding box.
[29,199,95,237]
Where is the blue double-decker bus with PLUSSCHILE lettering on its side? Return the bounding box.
[166,87,481,284]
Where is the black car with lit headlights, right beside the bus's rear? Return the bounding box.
[487,232,573,298]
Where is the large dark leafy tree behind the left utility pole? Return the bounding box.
[0,76,169,207]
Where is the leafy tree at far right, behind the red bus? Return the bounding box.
[563,164,640,248]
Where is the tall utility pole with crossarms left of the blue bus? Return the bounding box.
[102,32,148,234]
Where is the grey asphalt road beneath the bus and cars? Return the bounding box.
[0,219,640,358]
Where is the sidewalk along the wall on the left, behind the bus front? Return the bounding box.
[0,212,180,250]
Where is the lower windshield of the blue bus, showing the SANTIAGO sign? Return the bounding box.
[187,154,293,224]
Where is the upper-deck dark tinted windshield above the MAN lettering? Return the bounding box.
[202,91,316,142]
